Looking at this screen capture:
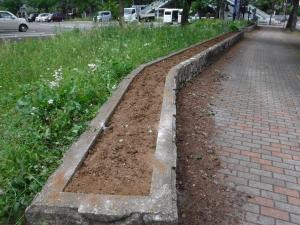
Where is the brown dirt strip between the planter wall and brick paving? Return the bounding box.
[176,46,247,225]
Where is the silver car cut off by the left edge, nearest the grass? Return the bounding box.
[0,11,29,32]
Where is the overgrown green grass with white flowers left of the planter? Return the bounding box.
[0,20,246,224]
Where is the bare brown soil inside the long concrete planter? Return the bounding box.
[65,34,232,195]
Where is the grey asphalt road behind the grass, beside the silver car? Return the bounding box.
[0,21,117,41]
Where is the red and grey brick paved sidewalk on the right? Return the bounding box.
[214,29,300,225]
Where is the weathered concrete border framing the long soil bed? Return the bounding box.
[26,29,250,225]
